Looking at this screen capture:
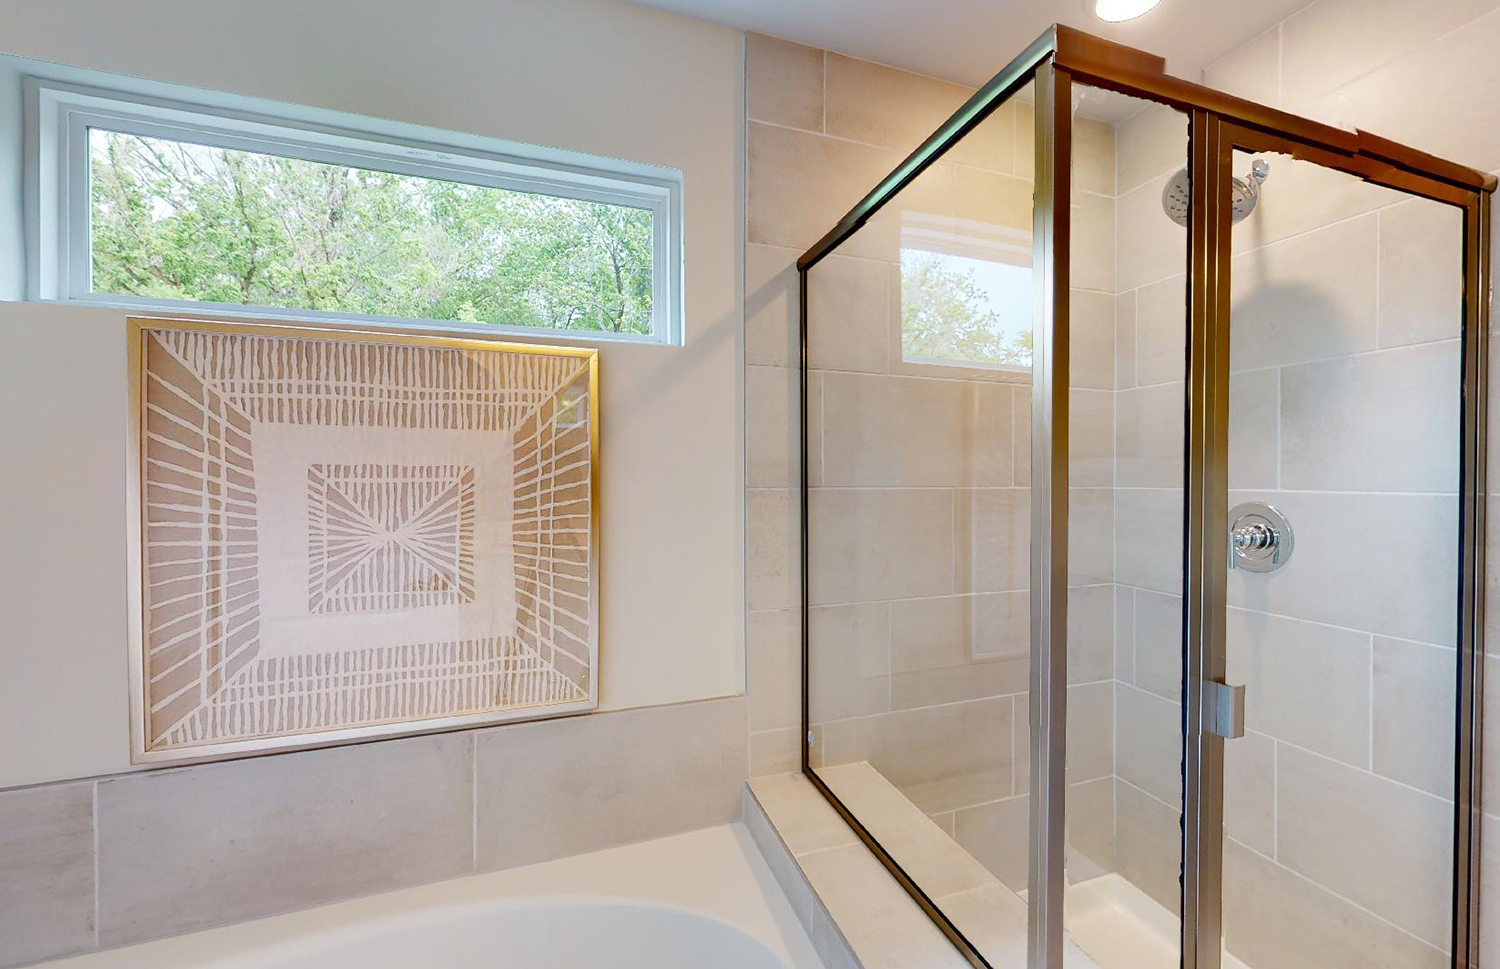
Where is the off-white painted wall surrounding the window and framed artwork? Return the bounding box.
[0,0,744,788]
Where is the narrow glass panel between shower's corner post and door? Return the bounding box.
[1064,86,1188,969]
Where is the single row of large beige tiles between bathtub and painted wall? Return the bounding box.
[0,698,747,966]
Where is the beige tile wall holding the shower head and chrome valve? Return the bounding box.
[1098,0,1500,966]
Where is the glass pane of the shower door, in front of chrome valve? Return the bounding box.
[1223,152,1463,969]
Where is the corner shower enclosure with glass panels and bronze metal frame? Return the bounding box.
[798,27,1496,969]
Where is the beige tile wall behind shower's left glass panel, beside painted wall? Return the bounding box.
[746,35,1115,906]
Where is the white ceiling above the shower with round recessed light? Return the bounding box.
[627,0,1310,87]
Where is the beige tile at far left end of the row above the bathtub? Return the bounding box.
[0,783,95,966]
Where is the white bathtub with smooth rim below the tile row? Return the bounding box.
[47,824,822,969]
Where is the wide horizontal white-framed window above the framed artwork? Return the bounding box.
[32,83,681,344]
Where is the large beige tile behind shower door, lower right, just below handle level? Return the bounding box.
[1277,746,1454,945]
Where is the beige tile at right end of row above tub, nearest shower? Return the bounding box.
[473,698,749,870]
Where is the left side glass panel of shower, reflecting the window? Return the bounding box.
[807,75,1034,965]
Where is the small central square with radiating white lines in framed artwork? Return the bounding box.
[308,465,474,614]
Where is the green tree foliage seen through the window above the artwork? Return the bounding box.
[89,128,653,335]
